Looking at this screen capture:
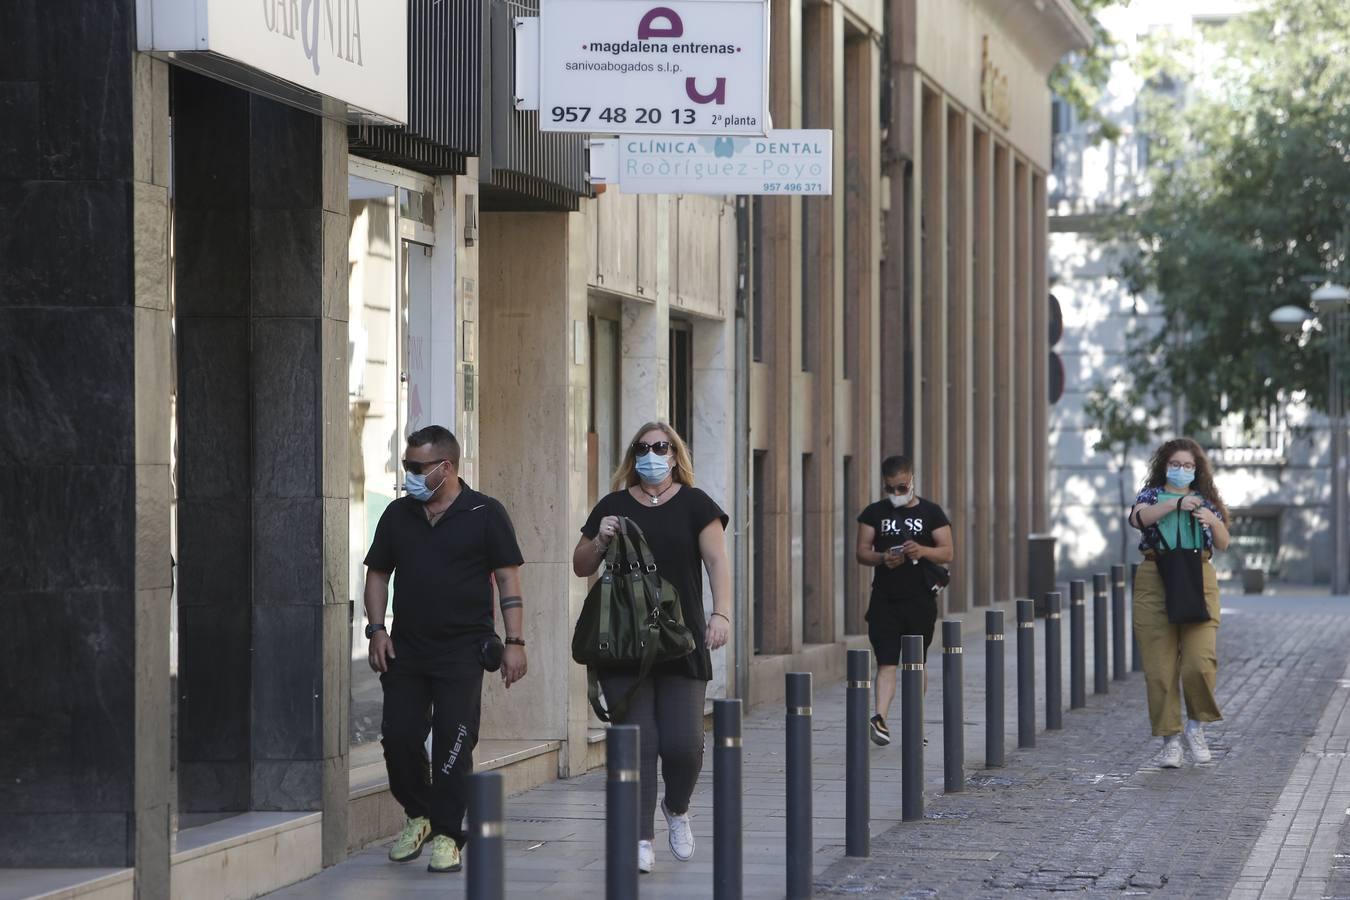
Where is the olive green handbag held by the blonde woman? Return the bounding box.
[572,518,694,722]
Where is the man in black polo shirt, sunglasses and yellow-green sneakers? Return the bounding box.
[366,425,525,872]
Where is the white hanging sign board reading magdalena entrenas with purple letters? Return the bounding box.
[537,0,770,135]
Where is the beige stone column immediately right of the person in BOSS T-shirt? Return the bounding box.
[944,108,973,613]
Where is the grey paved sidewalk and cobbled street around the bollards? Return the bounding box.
[274,596,1350,899]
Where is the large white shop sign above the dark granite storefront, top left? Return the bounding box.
[136,0,408,123]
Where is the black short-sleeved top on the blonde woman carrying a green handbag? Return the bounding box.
[582,486,728,681]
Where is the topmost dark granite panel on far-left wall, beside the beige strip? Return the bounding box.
[35,0,136,180]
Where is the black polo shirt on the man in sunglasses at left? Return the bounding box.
[366,479,525,658]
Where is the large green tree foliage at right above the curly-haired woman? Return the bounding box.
[1088,0,1350,449]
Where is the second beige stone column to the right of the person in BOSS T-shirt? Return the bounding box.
[963,128,1002,606]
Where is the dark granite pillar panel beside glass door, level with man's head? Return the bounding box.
[252,318,321,497]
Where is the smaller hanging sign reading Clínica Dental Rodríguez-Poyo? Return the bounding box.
[590,128,834,196]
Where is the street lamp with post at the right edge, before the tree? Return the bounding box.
[1270,281,1350,594]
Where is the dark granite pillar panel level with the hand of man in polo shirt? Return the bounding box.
[252,606,323,765]
